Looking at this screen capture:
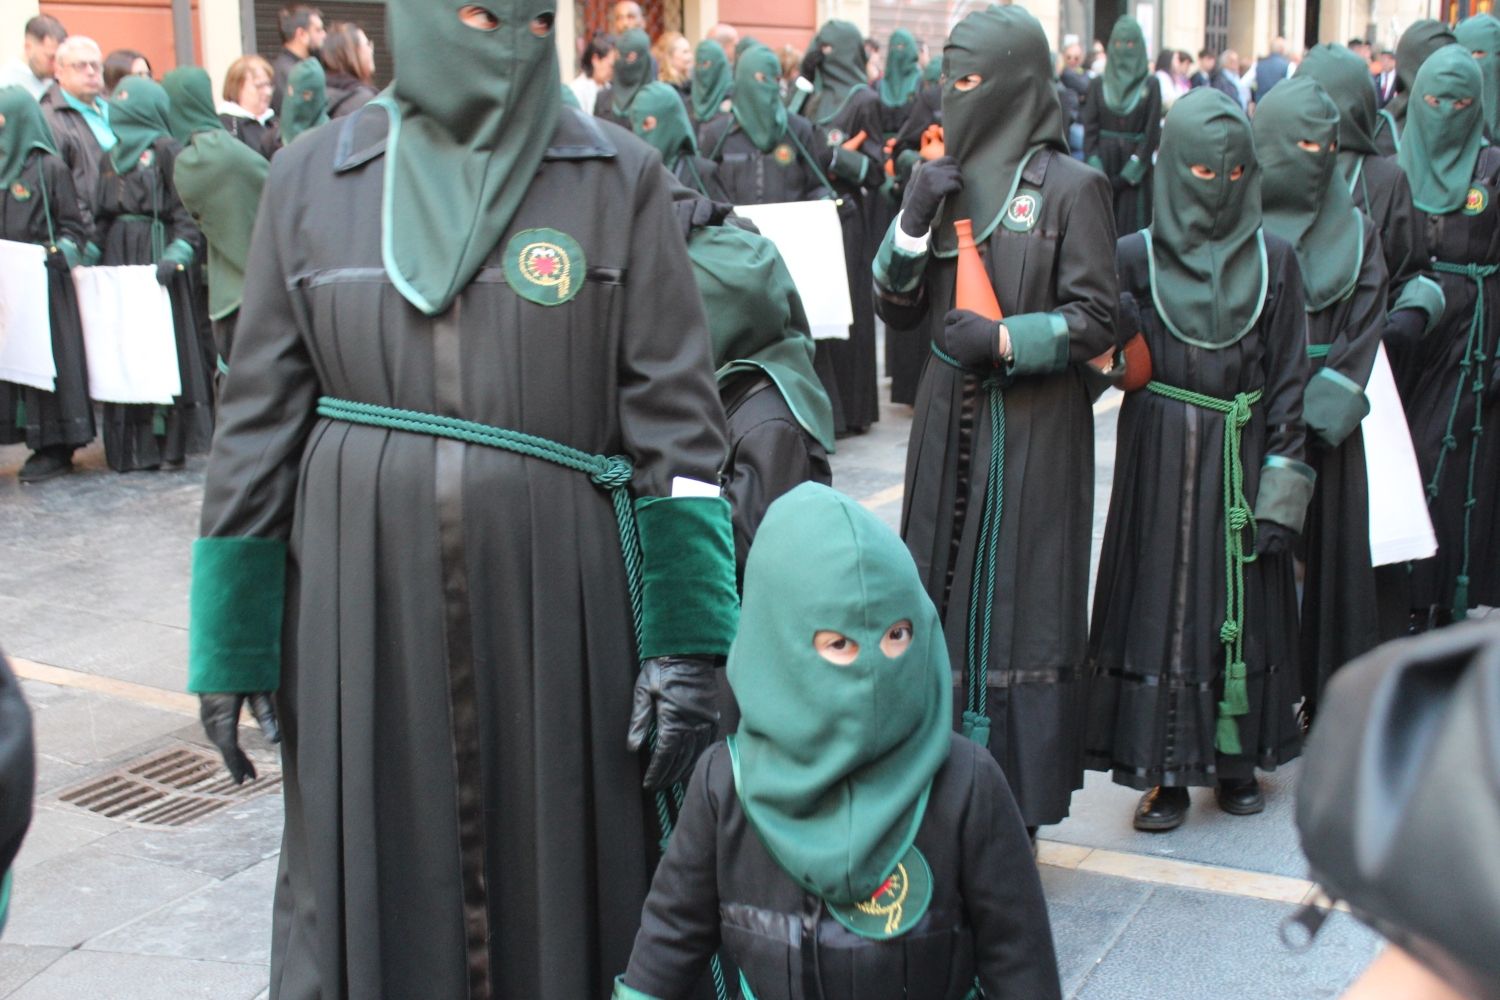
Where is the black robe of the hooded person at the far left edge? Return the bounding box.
[0,151,95,451]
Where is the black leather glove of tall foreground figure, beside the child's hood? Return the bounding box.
[626,657,719,792]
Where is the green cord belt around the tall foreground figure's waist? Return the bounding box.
[318,396,729,1000]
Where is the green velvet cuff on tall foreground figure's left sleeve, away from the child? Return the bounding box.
[188,538,287,694]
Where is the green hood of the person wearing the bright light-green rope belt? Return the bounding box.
[1146,84,1266,348]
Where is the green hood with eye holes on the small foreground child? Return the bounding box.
[729,483,953,904]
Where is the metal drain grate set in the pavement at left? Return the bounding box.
[59,745,281,826]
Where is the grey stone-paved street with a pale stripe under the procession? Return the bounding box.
[0,380,1379,1000]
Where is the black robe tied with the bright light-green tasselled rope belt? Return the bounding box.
[1088,235,1308,789]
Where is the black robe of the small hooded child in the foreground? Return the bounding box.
[624,736,1062,1000]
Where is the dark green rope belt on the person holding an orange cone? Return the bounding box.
[932,343,1005,747]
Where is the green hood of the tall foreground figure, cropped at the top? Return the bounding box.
[374,0,563,316]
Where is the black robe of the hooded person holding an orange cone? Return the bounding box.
[876,150,1119,826]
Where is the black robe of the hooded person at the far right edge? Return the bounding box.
[1400,148,1500,609]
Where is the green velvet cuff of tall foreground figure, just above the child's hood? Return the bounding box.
[636,496,740,660]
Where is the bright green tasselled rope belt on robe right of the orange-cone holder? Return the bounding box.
[1146,379,1262,756]
